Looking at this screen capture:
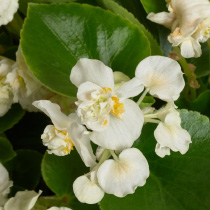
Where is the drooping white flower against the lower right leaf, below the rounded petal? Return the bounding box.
[154,105,191,157]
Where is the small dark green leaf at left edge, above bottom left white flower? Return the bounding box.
[0,137,16,162]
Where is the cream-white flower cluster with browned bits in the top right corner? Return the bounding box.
[147,0,210,58]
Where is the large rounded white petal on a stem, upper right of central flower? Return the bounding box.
[136,56,185,101]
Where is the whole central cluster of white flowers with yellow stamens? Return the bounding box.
[33,56,191,204]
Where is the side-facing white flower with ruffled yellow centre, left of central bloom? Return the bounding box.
[33,100,96,167]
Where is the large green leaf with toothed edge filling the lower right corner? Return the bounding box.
[100,110,210,210]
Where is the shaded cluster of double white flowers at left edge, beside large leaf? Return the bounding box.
[0,47,64,117]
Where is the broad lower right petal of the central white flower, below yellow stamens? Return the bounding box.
[90,99,144,150]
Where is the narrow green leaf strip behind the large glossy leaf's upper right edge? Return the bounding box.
[97,0,162,55]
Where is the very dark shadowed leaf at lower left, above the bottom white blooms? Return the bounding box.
[4,150,42,190]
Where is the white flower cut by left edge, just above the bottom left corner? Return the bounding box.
[0,163,13,206]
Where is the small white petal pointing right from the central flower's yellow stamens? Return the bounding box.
[116,78,144,98]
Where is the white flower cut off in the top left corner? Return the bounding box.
[0,0,19,26]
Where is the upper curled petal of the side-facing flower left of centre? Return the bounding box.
[33,100,70,130]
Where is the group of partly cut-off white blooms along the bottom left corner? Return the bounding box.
[0,163,71,210]
